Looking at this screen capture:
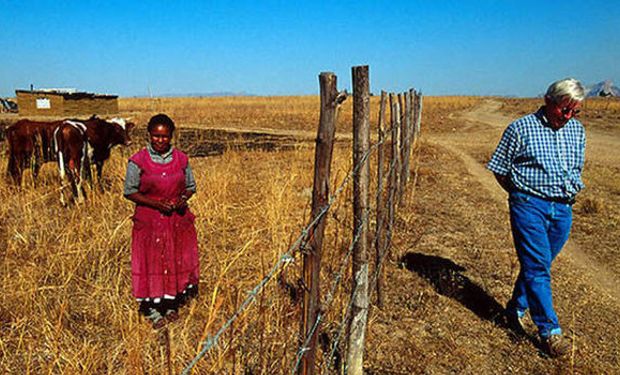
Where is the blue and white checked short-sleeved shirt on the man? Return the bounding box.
[487,108,586,198]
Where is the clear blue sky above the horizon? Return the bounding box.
[0,0,620,96]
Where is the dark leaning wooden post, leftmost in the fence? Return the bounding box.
[299,72,344,375]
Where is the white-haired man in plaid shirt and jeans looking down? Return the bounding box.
[487,78,586,357]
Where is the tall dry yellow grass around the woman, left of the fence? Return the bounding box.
[0,93,406,373]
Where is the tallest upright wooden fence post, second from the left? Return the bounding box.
[347,65,370,375]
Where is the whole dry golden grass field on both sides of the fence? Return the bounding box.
[0,96,620,374]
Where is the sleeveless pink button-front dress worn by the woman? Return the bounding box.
[130,149,199,298]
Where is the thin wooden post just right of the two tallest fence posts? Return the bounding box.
[375,91,387,306]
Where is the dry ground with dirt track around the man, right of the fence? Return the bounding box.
[376,101,620,374]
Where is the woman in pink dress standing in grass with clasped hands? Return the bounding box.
[124,114,198,329]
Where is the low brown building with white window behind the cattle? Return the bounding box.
[15,89,118,117]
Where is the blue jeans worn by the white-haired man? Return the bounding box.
[508,192,573,337]
